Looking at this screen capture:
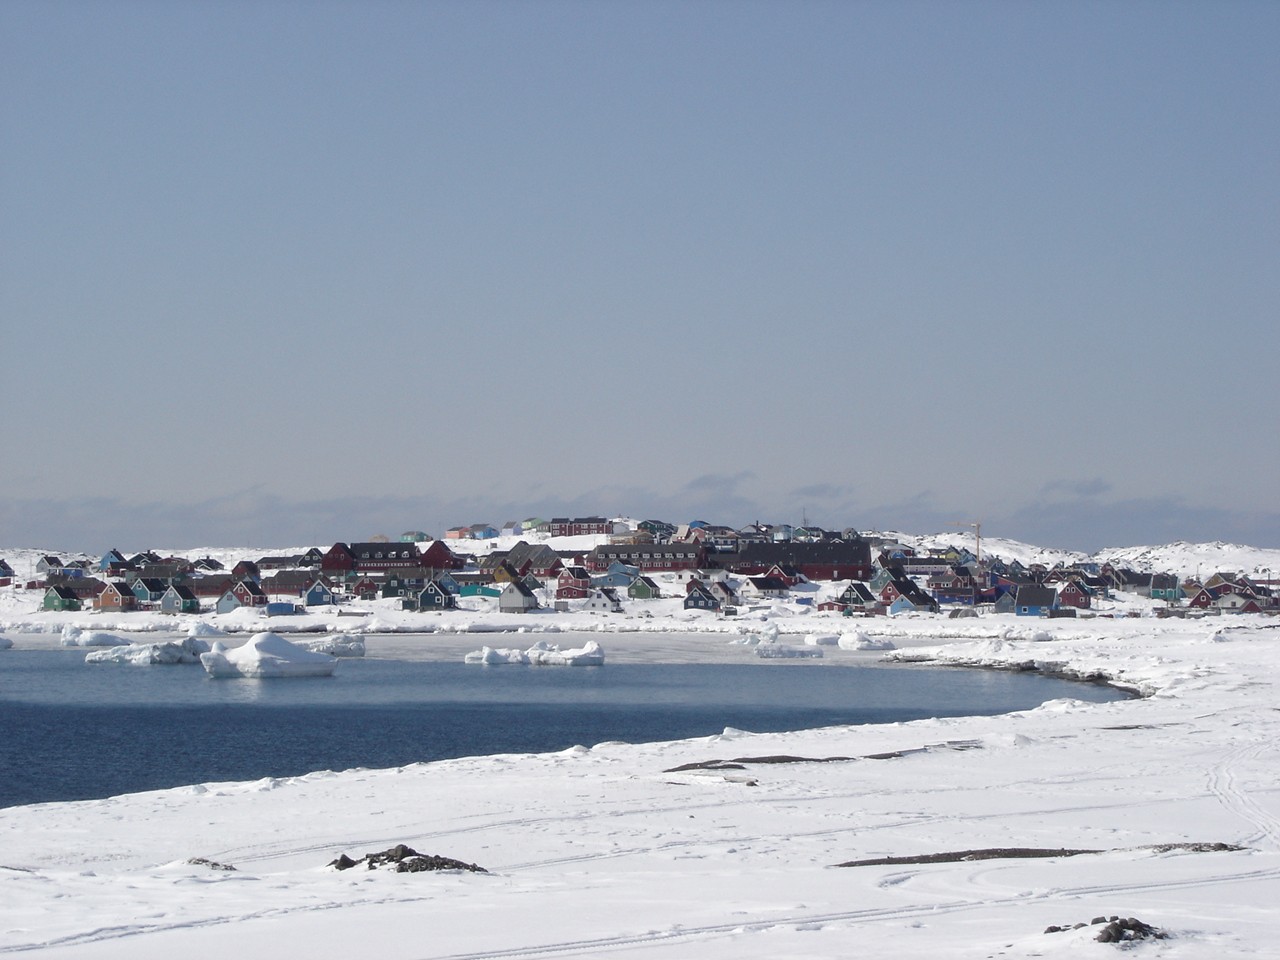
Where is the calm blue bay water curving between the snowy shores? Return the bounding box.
[0,650,1121,806]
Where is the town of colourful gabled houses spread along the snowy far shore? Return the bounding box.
[0,517,1280,617]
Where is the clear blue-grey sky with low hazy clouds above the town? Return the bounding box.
[0,0,1280,550]
